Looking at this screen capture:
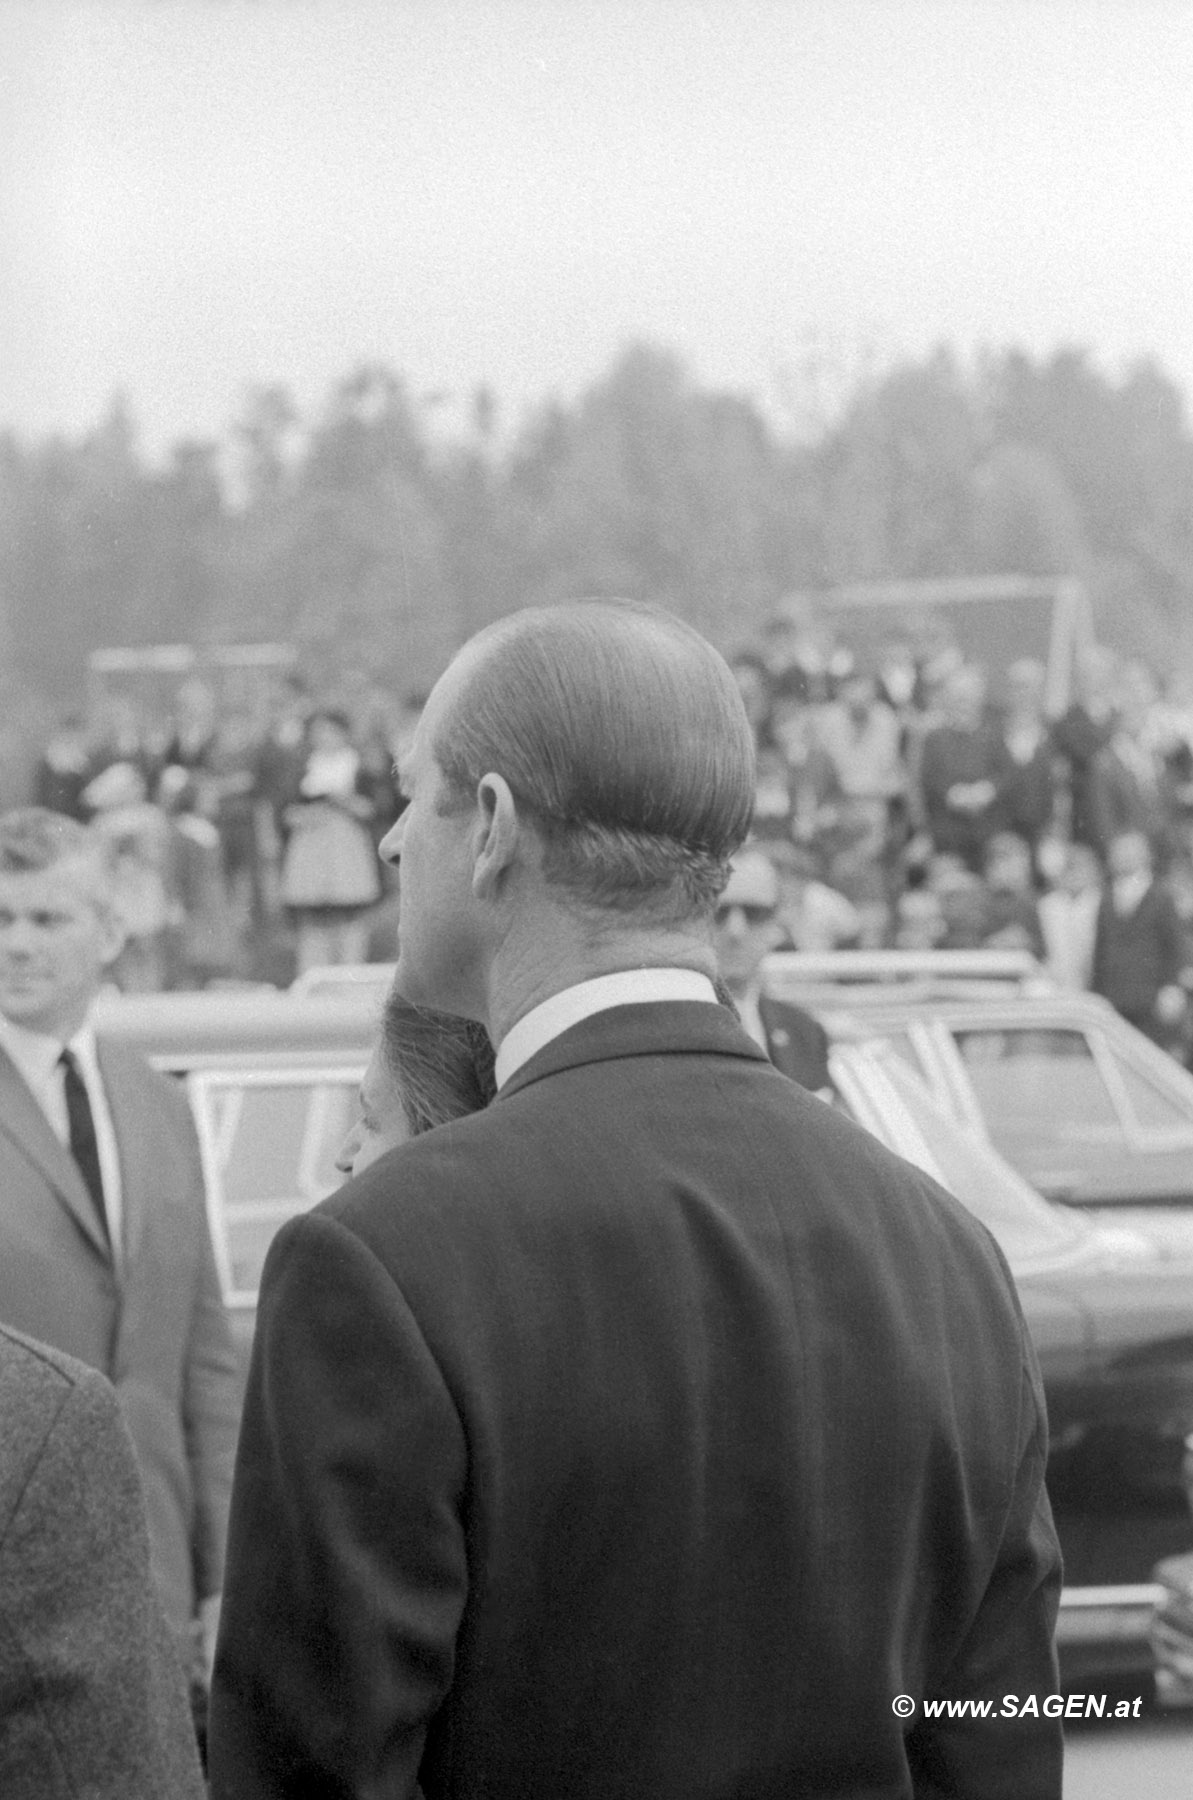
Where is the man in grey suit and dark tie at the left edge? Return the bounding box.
[0,808,238,1706]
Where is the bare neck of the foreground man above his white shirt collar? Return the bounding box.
[488,911,716,1048]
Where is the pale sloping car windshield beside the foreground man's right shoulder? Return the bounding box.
[867,1053,1085,1269]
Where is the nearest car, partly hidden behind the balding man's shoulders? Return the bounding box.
[93,972,1193,1683]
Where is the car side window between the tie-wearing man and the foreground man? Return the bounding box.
[187,1069,362,1307]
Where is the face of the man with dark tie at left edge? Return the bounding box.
[0,857,122,1037]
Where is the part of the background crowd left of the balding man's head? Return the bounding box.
[29,675,417,992]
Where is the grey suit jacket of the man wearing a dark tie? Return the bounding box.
[0,1040,238,1631]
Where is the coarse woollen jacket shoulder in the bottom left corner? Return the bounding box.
[0,1328,203,1800]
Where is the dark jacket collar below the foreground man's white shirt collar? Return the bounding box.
[495,1001,768,1103]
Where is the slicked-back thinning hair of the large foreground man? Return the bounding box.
[432,601,754,922]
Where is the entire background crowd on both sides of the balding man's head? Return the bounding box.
[18,625,1193,1060]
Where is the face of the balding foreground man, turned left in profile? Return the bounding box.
[381,664,477,1013]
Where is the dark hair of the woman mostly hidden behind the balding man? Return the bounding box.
[381,994,497,1138]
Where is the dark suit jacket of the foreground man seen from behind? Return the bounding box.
[211,1003,1060,1800]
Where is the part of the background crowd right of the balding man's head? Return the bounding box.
[732,615,1193,1057]
